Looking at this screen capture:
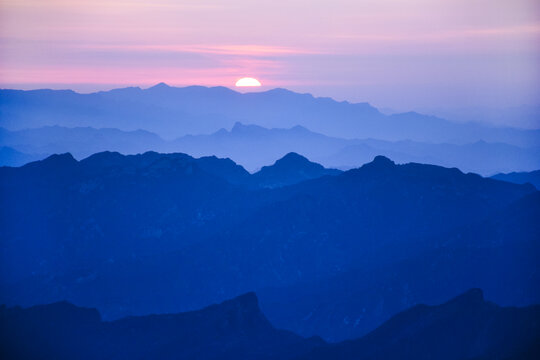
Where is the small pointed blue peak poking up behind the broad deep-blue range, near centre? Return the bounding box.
[253,153,341,188]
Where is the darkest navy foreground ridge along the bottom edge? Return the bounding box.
[0,289,540,360]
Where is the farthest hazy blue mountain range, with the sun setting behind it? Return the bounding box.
[0,84,540,146]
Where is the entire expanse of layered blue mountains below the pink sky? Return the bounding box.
[0,84,540,360]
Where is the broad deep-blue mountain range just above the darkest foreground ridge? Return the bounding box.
[0,153,540,338]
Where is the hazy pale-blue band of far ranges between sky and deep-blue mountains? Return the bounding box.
[0,84,540,175]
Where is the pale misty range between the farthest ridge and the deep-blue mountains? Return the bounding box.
[0,123,540,175]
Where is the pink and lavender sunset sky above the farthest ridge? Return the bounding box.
[0,0,540,110]
